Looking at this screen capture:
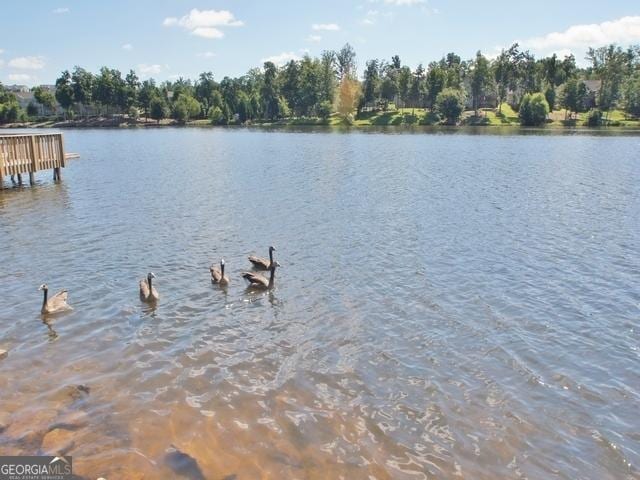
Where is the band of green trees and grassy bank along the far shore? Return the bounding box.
[0,43,640,129]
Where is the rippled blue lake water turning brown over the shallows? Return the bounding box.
[0,128,640,480]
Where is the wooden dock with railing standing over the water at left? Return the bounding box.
[0,133,79,189]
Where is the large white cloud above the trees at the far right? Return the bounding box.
[522,16,640,51]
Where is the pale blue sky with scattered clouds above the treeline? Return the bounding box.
[0,0,640,86]
